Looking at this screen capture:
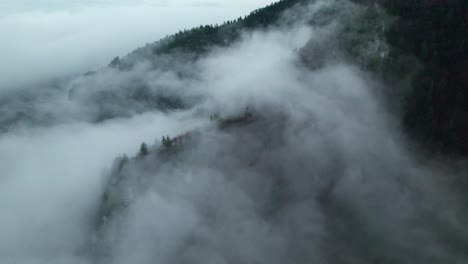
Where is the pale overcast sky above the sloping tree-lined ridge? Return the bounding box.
[0,0,272,90]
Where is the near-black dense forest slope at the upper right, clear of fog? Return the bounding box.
[379,0,468,154]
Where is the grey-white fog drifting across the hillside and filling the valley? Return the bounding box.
[0,0,468,264]
